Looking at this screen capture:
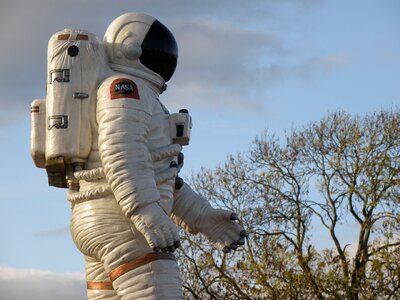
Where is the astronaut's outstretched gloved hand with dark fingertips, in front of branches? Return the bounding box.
[193,206,247,253]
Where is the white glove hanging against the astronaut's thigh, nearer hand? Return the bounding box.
[131,203,180,252]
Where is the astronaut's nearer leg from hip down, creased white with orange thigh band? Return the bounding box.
[71,196,183,300]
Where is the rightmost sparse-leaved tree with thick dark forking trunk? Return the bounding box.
[301,112,400,299]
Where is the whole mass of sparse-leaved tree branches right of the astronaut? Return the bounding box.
[180,110,400,299]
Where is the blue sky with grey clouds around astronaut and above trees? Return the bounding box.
[0,0,400,299]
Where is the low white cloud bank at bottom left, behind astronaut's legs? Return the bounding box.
[0,265,86,300]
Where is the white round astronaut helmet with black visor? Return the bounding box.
[104,13,178,83]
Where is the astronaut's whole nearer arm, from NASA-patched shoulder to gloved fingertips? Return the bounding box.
[97,79,179,250]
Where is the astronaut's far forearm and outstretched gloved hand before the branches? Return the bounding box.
[171,183,247,252]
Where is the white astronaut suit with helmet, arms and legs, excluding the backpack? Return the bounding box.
[32,13,245,300]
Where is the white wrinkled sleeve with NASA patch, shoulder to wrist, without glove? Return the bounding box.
[97,77,160,218]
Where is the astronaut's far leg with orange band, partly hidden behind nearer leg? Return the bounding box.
[86,256,121,300]
